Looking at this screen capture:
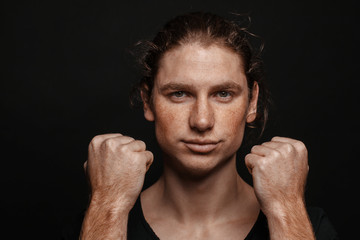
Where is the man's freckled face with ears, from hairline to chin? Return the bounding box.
[144,44,258,175]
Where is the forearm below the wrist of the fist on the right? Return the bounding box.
[267,201,315,240]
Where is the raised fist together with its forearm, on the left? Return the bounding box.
[79,134,153,240]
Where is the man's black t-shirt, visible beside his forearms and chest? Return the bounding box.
[61,198,339,240]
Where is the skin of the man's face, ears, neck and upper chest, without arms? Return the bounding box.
[142,44,259,239]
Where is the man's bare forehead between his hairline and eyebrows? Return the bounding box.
[155,43,246,87]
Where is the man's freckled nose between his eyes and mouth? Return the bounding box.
[189,98,215,132]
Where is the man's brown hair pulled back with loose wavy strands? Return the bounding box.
[130,12,269,140]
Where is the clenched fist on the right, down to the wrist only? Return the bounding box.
[245,137,309,215]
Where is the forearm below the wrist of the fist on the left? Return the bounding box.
[79,201,128,240]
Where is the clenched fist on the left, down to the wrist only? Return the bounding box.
[84,134,153,211]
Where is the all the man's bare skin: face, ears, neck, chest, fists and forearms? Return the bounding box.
[81,43,314,239]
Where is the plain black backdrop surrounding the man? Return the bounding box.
[0,0,360,239]
